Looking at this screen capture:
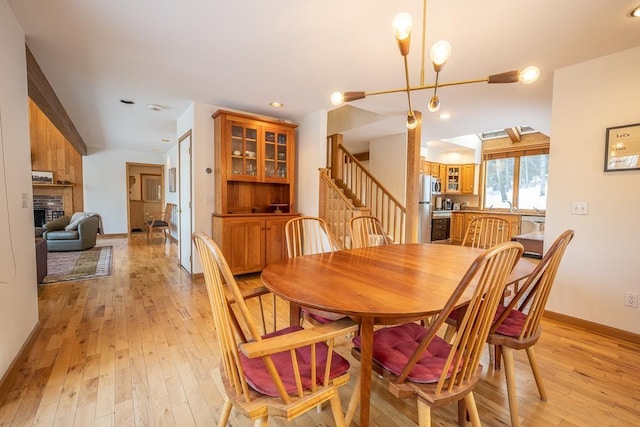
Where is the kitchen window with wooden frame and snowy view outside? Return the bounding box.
[484,148,549,210]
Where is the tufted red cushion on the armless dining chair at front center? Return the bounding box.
[353,323,452,383]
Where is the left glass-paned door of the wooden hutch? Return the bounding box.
[231,122,258,178]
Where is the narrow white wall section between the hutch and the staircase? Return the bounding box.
[296,111,327,216]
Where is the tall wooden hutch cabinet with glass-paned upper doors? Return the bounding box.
[212,110,298,274]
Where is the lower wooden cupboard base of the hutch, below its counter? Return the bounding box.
[211,214,297,274]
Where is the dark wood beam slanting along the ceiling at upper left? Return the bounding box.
[25,45,87,156]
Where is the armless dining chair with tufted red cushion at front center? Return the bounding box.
[346,242,523,427]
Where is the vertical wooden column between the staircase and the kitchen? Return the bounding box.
[405,111,422,243]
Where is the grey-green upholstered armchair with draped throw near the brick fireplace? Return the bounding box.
[42,212,101,252]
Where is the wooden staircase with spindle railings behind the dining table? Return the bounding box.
[319,135,406,248]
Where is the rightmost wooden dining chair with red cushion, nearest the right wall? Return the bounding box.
[487,230,574,426]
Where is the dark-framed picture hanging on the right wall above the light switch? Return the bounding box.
[604,123,640,172]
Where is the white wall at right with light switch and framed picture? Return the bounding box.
[545,48,640,333]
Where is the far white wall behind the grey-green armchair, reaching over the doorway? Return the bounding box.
[82,147,167,234]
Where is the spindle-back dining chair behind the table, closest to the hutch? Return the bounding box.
[284,216,344,325]
